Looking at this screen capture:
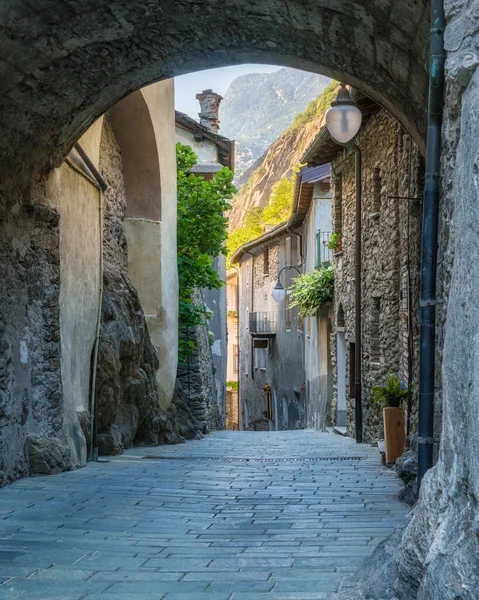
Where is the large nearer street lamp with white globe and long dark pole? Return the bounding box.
[326,83,363,444]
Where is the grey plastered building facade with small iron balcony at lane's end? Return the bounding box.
[231,224,305,431]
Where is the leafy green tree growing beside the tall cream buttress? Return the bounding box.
[176,143,236,361]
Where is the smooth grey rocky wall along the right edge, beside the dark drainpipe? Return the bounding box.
[397,0,479,600]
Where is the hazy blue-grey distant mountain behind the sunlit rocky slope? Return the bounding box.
[220,68,331,184]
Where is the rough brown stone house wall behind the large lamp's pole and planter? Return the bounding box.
[331,110,423,442]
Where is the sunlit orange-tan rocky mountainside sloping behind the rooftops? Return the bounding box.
[228,81,338,236]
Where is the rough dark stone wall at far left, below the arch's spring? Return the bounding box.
[0,183,71,485]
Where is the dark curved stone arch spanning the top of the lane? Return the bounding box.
[0,0,429,176]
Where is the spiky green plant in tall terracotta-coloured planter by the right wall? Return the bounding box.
[372,375,408,463]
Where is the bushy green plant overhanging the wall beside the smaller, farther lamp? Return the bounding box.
[291,267,334,317]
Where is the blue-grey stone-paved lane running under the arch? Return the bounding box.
[0,431,408,600]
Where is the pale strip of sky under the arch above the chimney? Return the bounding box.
[175,64,281,119]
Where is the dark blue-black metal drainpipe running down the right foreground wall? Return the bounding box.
[417,0,446,492]
